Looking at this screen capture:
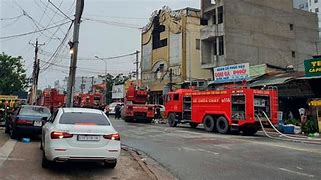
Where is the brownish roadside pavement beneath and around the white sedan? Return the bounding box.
[0,130,150,180]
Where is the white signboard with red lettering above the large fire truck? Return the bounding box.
[214,63,250,83]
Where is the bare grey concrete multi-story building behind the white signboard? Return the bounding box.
[201,0,318,70]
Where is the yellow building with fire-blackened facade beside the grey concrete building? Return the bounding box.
[141,7,212,103]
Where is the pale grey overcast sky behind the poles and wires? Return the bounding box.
[0,0,200,89]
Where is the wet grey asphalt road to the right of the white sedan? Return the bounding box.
[112,120,321,180]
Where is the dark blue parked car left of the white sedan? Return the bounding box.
[5,105,51,139]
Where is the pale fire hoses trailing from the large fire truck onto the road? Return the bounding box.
[256,111,321,145]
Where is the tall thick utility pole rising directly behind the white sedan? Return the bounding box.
[66,0,84,107]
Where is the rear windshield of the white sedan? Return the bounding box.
[59,112,110,126]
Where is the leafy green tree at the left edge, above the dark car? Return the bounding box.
[0,53,28,95]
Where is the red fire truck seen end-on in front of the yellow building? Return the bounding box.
[122,84,155,123]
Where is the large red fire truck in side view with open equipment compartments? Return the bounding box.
[165,88,278,135]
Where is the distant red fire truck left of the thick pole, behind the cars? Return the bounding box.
[37,88,65,112]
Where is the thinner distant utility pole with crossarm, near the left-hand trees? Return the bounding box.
[29,39,45,104]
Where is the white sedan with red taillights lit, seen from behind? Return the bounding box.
[40,108,120,168]
